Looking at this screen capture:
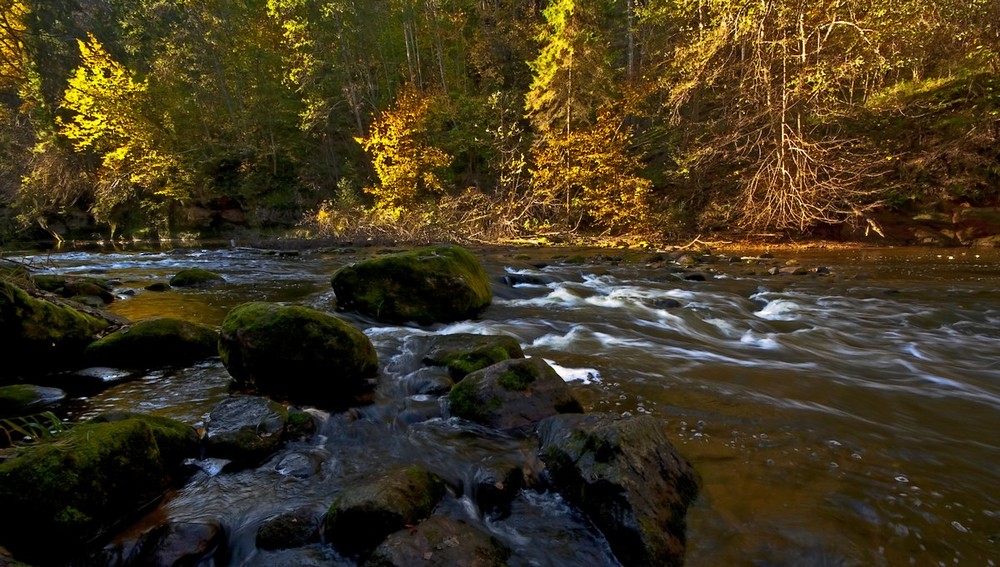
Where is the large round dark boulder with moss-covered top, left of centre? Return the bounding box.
[219,302,378,408]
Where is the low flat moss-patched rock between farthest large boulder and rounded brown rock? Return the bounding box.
[424,333,524,380]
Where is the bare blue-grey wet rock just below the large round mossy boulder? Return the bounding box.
[205,396,288,467]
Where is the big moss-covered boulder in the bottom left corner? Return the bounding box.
[0,415,198,565]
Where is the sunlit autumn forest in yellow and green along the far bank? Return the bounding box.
[0,0,1000,242]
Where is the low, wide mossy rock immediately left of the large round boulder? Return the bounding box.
[84,317,219,368]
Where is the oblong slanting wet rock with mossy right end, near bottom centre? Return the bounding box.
[323,467,445,556]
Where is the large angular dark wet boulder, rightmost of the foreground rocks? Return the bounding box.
[538,414,699,567]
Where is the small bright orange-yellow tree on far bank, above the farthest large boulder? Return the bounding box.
[357,91,451,220]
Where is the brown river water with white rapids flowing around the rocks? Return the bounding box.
[7,248,1000,566]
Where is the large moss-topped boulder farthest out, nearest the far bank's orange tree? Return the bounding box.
[331,246,493,325]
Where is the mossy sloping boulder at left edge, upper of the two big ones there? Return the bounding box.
[0,281,109,377]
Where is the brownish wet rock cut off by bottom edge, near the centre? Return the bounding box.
[365,516,510,567]
